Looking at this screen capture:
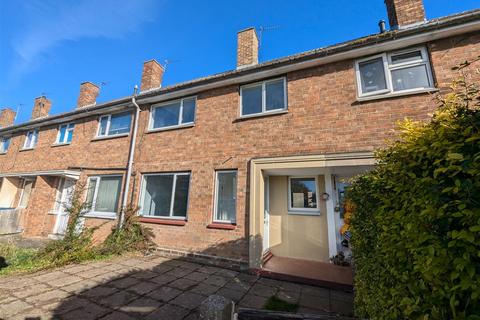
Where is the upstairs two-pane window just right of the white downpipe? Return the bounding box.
[150,97,196,130]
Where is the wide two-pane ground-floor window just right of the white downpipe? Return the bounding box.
[141,173,190,219]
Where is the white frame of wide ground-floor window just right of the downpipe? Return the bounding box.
[138,171,192,221]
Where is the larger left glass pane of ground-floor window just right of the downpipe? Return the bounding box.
[142,175,173,217]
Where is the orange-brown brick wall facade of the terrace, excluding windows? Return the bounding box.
[0,8,480,261]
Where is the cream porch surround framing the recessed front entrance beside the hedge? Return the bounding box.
[249,152,375,269]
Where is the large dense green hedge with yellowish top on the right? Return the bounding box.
[347,63,480,319]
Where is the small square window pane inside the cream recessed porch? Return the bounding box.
[290,178,317,208]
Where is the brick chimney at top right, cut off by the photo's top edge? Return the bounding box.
[385,0,425,30]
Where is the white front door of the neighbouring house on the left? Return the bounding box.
[53,178,75,236]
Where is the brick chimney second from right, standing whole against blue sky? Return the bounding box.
[237,27,258,69]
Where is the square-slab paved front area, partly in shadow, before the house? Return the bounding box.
[0,255,353,320]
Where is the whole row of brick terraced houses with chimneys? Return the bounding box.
[0,0,480,283]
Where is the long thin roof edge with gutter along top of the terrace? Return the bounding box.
[0,9,480,133]
